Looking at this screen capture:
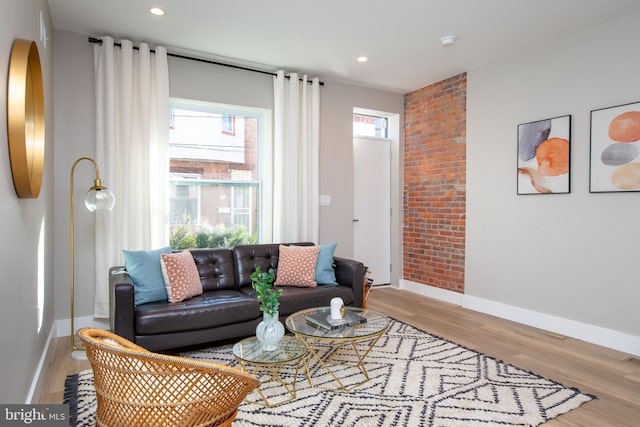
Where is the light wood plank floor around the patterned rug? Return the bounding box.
[37,287,640,427]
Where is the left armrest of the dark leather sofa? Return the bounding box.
[109,267,135,342]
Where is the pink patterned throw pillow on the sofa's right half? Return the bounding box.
[274,245,320,288]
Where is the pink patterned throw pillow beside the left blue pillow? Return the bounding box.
[160,251,202,303]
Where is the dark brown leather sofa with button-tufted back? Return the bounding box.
[109,242,365,351]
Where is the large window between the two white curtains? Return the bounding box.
[169,99,265,249]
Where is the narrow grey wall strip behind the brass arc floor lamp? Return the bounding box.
[53,30,96,335]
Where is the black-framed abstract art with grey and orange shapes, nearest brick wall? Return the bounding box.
[518,115,571,194]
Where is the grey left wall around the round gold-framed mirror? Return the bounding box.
[0,0,55,403]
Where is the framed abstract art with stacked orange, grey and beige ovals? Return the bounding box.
[589,102,640,193]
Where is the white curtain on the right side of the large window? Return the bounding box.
[273,71,320,243]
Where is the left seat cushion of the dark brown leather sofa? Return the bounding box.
[134,290,262,335]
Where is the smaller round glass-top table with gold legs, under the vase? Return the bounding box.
[233,336,307,408]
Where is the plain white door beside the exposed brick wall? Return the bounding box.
[353,137,391,285]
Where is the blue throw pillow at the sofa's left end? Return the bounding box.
[122,246,171,305]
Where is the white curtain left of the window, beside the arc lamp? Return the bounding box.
[94,37,169,317]
